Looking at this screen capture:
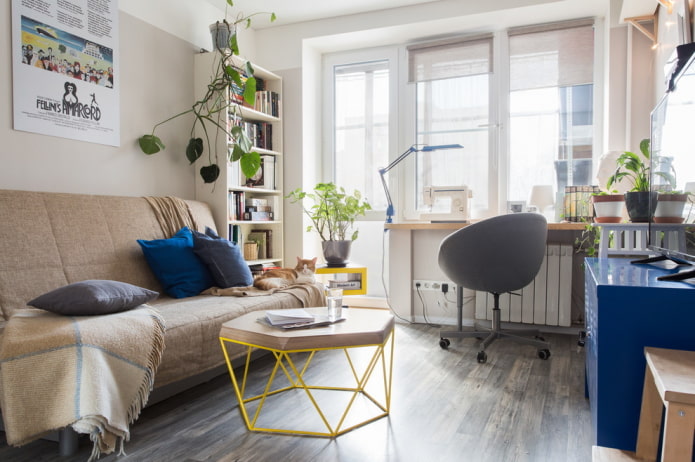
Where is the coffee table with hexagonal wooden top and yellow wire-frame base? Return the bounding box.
[220,307,395,438]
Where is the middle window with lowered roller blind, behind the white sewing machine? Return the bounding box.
[408,35,494,217]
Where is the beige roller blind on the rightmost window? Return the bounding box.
[509,19,594,91]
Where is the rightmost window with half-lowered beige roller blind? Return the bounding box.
[507,21,594,201]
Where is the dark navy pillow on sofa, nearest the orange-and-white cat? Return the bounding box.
[193,227,253,289]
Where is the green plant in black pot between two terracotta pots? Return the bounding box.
[607,139,657,223]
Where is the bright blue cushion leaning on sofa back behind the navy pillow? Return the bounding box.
[138,226,214,298]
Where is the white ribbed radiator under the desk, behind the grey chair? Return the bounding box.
[475,244,574,326]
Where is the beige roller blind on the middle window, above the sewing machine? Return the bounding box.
[408,34,492,83]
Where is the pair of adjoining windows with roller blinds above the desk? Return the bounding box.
[408,20,594,217]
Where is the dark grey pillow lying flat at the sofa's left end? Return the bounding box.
[27,280,159,316]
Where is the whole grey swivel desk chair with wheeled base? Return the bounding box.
[439,213,550,363]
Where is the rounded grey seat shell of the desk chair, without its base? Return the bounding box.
[439,213,548,294]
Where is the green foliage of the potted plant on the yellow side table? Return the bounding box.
[285,183,372,241]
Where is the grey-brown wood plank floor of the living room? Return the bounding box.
[0,324,591,462]
